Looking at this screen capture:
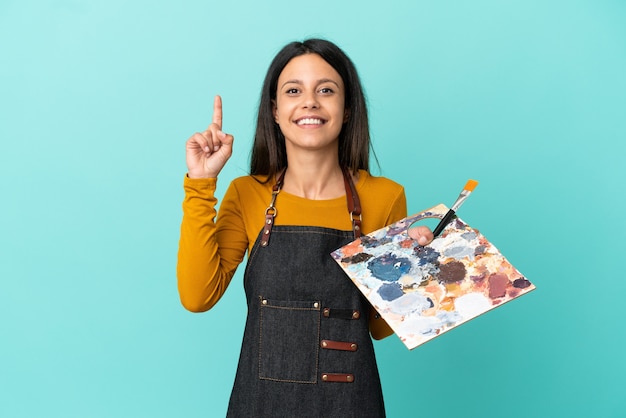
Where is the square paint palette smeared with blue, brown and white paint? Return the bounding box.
[331,204,535,350]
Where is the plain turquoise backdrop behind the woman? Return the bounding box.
[0,0,626,417]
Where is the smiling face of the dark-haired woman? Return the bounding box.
[273,54,347,153]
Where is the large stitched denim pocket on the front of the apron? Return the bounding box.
[259,298,320,383]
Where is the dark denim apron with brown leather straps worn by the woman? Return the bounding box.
[227,168,385,417]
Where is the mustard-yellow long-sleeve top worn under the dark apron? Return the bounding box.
[177,170,407,338]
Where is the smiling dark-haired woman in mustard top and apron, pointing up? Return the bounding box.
[178,39,432,417]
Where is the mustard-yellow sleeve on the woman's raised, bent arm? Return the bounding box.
[176,177,247,312]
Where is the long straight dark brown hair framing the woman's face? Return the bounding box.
[250,39,370,178]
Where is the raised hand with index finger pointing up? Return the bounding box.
[186,96,234,179]
